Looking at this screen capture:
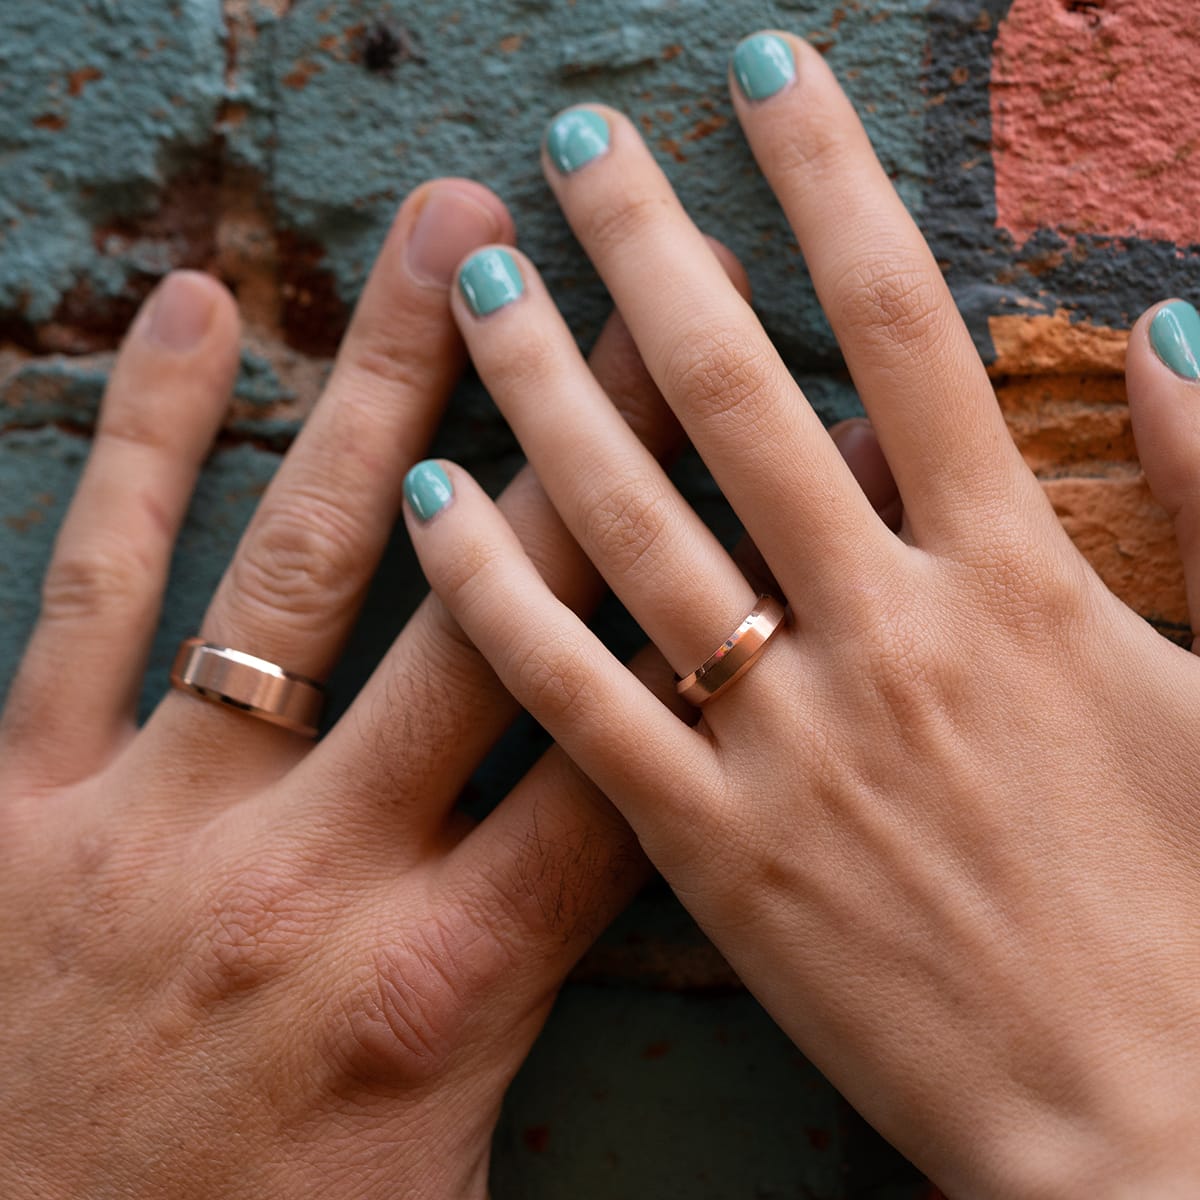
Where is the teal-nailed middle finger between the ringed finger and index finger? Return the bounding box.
[545,107,899,610]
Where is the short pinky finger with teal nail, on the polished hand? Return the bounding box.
[404,462,716,832]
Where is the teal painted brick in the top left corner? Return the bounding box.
[0,0,224,323]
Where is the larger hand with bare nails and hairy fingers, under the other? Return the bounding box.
[0,180,745,1200]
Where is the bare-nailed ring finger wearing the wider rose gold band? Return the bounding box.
[149,180,511,766]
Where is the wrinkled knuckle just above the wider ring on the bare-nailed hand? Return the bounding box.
[229,492,366,620]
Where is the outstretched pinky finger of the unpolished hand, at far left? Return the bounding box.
[0,271,238,784]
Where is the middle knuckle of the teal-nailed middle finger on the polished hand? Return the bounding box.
[664,324,779,428]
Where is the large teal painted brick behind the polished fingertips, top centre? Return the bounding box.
[258,0,926,365]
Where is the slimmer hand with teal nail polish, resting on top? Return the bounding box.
[408,35,1200,1200]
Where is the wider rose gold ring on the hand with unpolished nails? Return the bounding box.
[170,637,325,738]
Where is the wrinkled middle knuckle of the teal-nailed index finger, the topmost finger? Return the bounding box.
[835,254,949,361]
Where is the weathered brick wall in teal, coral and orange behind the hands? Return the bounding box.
[0,0,1200,1200]
